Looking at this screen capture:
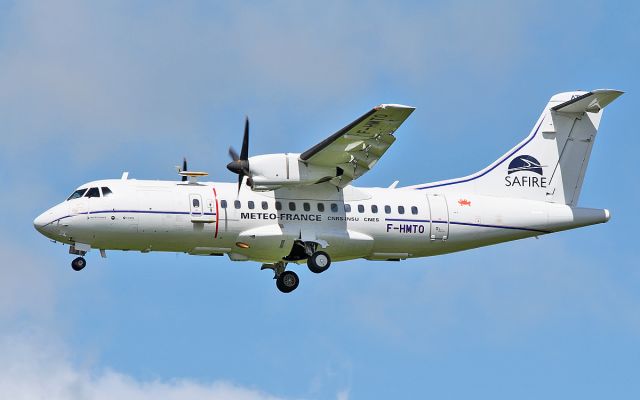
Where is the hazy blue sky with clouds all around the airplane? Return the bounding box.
[0,0,640,399]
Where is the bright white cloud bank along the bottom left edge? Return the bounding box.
[0,336,278,400]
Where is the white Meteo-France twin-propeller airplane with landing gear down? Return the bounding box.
[33,89,623,293]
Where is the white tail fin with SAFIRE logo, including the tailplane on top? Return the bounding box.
[411,89,623,206]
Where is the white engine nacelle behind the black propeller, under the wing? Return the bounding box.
[249,153,338,191]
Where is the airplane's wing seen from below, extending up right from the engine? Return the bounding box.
[300,104,415,187]
